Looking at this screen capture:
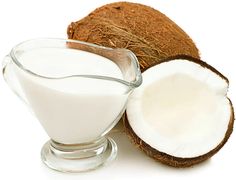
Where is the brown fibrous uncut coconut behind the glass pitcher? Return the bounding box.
[67,2,199,71]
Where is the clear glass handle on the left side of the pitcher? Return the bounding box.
[2,55,29,105]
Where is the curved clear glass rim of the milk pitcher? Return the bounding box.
[9,38,142,88]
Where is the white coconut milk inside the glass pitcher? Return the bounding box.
[15,48,127,144]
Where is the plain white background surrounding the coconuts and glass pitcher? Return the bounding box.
[0,0,236,180]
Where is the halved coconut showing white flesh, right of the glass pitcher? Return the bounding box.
[124,56,234,167]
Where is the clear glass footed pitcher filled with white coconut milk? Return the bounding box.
[3,39,142,172]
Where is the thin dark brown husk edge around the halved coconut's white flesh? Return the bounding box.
[123,55,234,168]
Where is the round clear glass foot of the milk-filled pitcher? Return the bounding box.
[41,138,117,172]
